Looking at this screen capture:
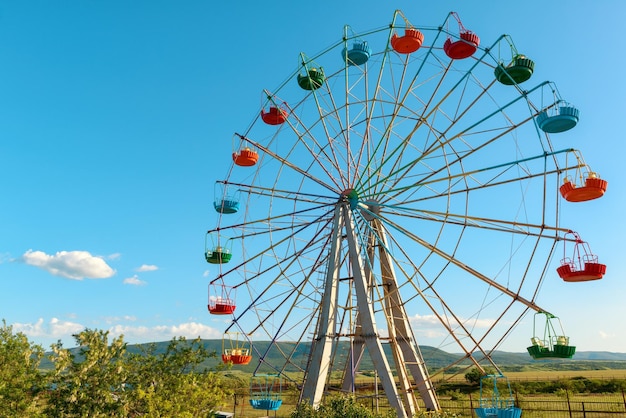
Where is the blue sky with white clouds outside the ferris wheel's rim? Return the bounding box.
[0,0,626,352]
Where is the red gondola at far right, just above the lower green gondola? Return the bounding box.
[556,231,606,282]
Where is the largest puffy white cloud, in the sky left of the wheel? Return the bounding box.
[21,250,115,280]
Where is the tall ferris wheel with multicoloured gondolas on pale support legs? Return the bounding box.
[206,11,606,416]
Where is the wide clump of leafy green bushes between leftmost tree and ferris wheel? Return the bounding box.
[46,329,229,418]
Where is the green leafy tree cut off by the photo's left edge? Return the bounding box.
[0,320,44,417]
